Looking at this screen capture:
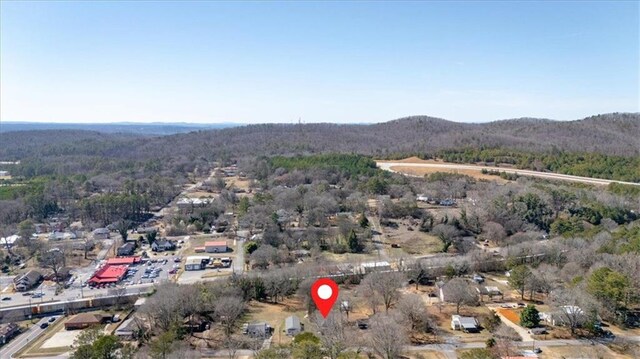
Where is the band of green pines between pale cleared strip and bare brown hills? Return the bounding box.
[435,148,640,182]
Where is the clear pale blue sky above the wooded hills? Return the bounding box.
[0,1,640,123]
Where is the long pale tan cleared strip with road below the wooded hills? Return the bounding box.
[376,162,640,186]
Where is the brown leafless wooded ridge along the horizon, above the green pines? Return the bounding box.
[0,113,640,160]
